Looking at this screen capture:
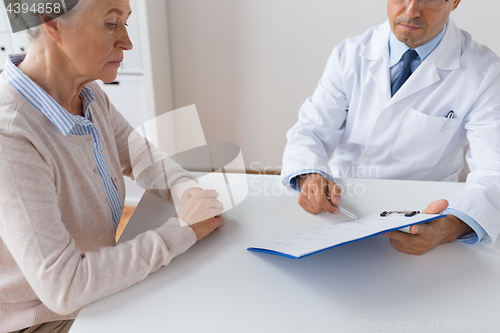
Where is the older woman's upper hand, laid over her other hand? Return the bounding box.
[177,188,224,225]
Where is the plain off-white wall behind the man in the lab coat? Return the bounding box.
[168,0,500,169]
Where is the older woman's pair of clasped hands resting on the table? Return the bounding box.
[177,189,225,240]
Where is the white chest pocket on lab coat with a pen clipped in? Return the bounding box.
[392,109,458,168]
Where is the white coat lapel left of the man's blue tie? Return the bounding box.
[360,21,391,105]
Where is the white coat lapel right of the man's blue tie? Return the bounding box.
[389,19,462,105]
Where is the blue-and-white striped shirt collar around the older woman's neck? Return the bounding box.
[3,53,95,136]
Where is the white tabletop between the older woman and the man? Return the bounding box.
[71,176,500,333]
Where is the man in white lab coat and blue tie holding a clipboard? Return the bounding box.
[282,0,500,254]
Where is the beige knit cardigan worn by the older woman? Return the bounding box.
[0,75,196,333]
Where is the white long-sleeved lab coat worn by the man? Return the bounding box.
[282,19,500,244]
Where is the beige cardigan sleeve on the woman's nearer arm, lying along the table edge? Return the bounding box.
[0,130,196,315]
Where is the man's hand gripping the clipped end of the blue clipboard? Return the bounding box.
[384,200,473,255]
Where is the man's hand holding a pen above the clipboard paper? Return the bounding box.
[299,173,341,214]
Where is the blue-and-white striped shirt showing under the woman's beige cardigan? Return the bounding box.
[3,54,123,231]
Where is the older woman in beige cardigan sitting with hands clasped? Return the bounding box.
[0,0,224,333]
